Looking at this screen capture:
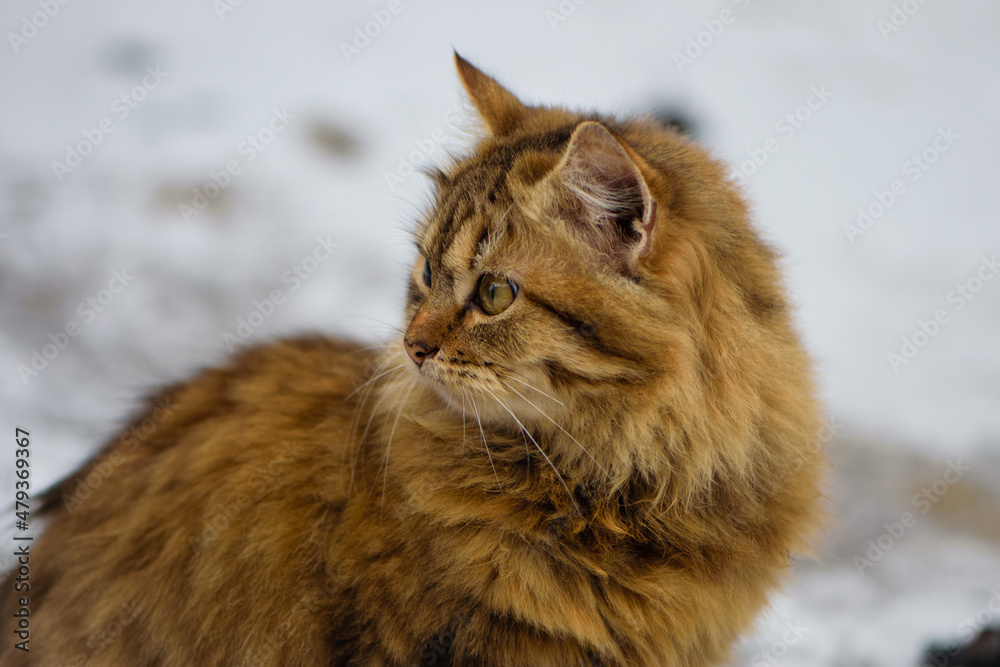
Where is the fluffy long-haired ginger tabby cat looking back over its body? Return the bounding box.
[0,57,823,667]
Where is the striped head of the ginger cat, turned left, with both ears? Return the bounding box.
[400,54,800,478]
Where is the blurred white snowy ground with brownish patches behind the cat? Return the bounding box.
[0,0,1000,667]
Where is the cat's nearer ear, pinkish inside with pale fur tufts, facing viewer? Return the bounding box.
[553,121,656,269]
